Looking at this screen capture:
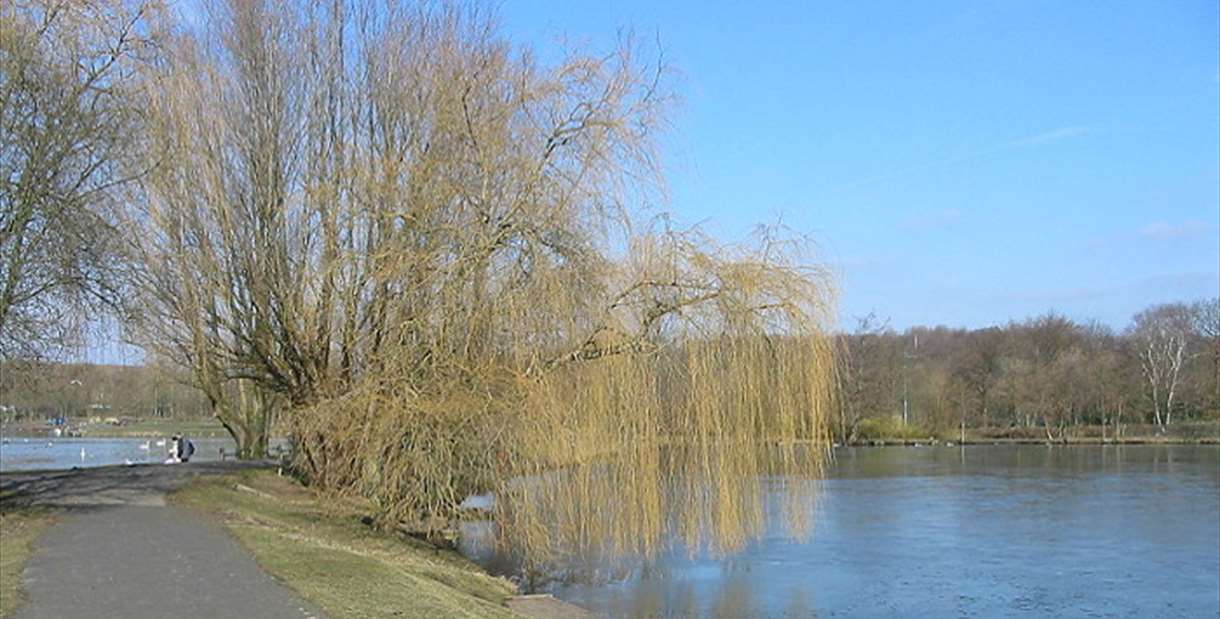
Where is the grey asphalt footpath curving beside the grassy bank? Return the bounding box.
[0,463,323,619]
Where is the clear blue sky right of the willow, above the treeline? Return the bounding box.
[499,0,1220,328]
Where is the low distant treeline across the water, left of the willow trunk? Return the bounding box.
[0,361,211,420]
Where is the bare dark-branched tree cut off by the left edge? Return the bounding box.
[0,0,157,357]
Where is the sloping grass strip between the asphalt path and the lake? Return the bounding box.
[171,471,520,619]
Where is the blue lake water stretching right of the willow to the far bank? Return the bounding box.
[467,446,1220,618]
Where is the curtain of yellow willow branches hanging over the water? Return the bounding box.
[507,337,832,558]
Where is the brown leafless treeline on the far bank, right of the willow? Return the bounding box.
[834,299,1220,441]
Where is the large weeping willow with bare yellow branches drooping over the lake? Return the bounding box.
[133,0,834,562]
